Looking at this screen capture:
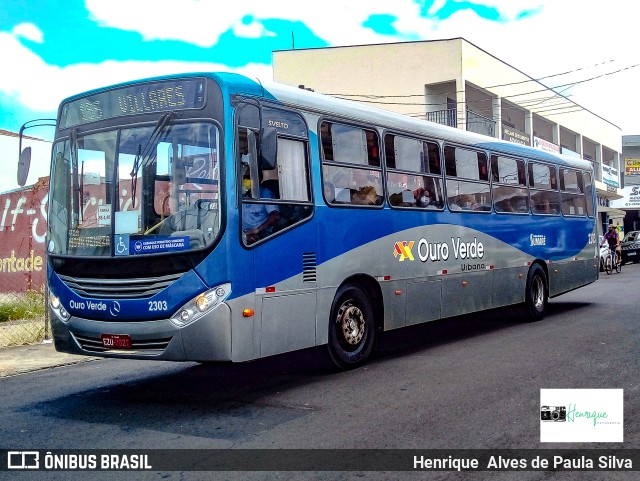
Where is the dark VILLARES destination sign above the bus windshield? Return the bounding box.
[59,79,205,129]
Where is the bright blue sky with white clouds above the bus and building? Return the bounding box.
[0,0,640,191]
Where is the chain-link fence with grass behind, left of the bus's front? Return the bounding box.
[0,285,51,349]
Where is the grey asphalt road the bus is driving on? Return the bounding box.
[0,265,640,480]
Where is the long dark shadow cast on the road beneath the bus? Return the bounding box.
[25,302,590,443]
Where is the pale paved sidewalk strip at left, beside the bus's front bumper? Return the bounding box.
[0,343,97,377]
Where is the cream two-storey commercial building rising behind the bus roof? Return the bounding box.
[273,38,624,230]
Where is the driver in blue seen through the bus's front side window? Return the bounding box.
[242,169,280,244]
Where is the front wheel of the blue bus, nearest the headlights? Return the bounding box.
[327,284,376,370]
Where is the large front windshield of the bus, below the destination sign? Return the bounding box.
[47,122,221,257]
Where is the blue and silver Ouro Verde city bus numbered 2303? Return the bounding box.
[32,73,598,368]
